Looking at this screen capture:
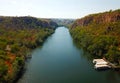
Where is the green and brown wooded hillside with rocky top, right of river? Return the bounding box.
[70,9,120,65]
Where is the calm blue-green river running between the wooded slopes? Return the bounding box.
[18,27,120,83]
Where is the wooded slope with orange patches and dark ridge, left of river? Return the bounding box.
[0,16,58,83]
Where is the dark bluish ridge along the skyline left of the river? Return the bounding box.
[0,16,58,28]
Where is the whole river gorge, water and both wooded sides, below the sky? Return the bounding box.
[0,9,120,83]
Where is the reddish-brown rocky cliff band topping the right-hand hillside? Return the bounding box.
[72,9,120,28]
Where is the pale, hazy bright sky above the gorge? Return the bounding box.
[0,0,120,18]
